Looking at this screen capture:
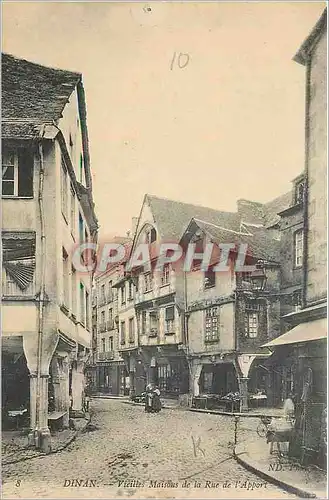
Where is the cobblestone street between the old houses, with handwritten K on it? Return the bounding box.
[2,400,294,498]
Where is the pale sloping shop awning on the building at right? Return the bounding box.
[262,318,327,347]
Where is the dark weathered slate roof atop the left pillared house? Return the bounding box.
[1,54,81,138]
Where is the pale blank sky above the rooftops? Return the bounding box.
[2,2,325,236]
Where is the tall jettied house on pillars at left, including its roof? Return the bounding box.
[2,54,97,450]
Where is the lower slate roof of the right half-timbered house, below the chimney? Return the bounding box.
[194,218,280,262]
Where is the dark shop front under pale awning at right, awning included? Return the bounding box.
[267,319,327,466]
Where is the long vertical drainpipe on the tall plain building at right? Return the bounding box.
[302,57,311,307]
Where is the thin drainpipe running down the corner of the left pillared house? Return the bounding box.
[36,142,46,443]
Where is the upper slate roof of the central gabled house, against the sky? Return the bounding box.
[146,195,240,242]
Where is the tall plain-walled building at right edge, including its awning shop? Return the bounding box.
[267,9,327,466]
